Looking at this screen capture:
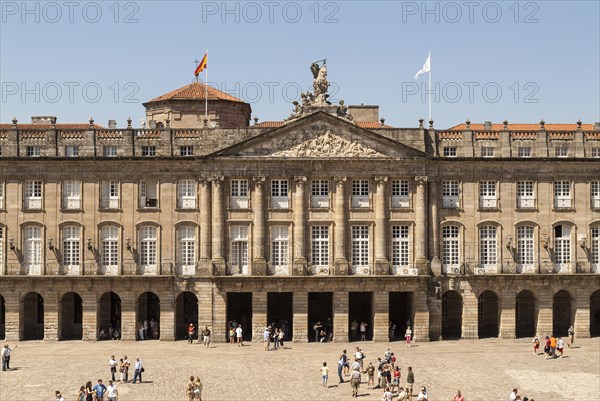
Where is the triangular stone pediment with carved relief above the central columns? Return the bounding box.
[213,112,427,159]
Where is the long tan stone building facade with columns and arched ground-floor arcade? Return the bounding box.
[0,83,600,341]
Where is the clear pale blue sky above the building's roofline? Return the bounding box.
[0,0,600,128]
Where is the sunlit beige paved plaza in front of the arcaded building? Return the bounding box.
[0,338,600,401]
